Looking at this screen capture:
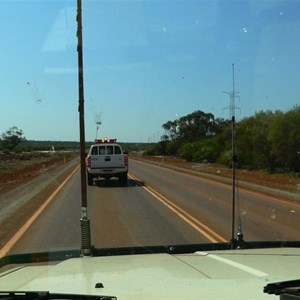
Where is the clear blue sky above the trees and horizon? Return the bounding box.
[0,0,300,142]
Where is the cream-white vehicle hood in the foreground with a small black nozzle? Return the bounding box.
[0,248,300,299]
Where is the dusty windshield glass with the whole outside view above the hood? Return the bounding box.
[0,0,300,257]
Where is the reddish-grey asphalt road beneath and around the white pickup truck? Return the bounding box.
[5,160,300,253]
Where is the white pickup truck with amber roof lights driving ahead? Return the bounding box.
[86,138,128,185]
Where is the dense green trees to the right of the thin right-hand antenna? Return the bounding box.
[237,106,300,172]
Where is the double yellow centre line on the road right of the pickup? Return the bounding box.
[128,174,227,243]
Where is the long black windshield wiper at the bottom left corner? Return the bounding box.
[0,291,117,300]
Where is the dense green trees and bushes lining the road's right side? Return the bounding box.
[144,106,300,176]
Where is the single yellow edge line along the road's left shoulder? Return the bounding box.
[0,165,80,258]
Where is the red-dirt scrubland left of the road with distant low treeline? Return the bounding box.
[0,126,153,193]
